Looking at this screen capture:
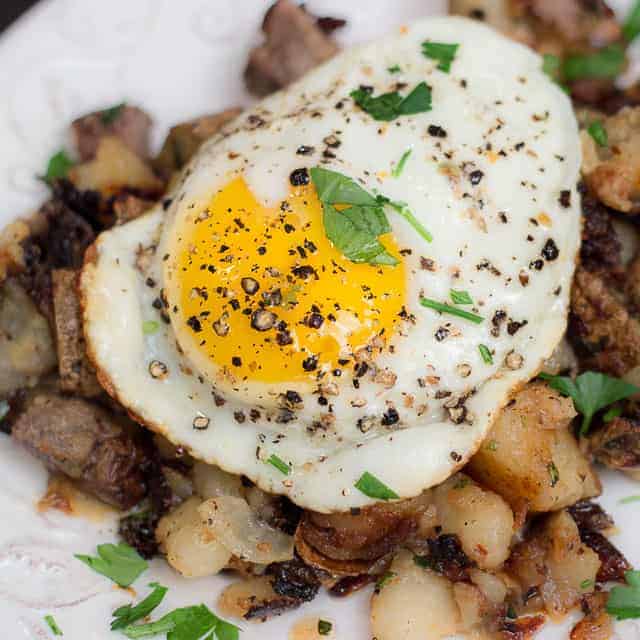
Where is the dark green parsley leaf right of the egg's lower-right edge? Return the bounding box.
[540,371,640,435]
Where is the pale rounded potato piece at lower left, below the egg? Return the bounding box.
[156,498,231,578]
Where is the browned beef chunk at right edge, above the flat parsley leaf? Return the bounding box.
[568,267,640,377]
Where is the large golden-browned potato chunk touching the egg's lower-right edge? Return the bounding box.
[465,382,601,512]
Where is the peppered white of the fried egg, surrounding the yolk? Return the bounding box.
[81,17,580,512]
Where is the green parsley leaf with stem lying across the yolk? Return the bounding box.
[309,167,431,265]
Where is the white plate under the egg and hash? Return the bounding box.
[0,0,640,640]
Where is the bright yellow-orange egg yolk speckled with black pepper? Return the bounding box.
[172,178,405,383]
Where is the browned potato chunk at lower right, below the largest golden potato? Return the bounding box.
[507,511,600,616]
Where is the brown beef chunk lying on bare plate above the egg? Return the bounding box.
[245,0,338,95]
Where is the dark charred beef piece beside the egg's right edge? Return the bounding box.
[580,189,622,273]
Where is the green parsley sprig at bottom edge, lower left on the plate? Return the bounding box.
[122,604,240,640]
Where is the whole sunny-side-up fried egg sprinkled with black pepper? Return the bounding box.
[80,17,580,512]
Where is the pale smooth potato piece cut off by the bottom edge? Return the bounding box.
[371,551,461,640]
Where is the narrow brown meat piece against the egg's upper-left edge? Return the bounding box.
[153,107,242,178]
